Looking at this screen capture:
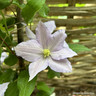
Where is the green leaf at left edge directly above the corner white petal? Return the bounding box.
[0,69,16,84]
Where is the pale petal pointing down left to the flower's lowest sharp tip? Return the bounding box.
[29,58,48,81]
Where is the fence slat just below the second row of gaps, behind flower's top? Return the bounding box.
[35,18,96,27]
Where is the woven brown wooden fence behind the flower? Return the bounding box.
[36,0,96,96]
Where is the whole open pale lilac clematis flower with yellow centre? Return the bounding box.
[15,21,77,81]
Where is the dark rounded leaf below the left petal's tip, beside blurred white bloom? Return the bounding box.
[4,53,18,66]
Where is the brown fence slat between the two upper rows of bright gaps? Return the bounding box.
[49,6,96,16]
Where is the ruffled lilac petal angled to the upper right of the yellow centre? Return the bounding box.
[48,29,67,51]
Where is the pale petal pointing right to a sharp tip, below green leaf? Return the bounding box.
[51,47,77,60]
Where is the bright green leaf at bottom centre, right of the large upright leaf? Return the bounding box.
[37,82,54,95]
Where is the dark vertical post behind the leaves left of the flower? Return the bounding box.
[17,0,25,70]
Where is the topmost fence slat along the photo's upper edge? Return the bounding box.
[46,0,96,4]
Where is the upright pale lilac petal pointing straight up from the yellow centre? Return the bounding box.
[36,21,51,49]
